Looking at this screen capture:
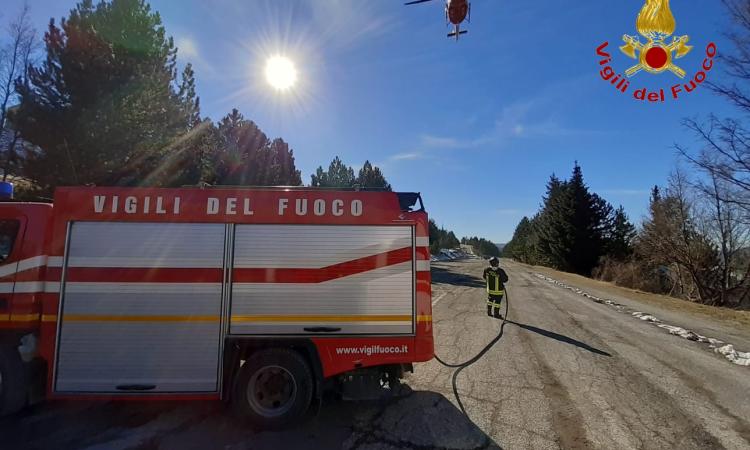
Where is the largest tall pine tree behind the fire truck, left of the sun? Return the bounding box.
[13,0,200,193]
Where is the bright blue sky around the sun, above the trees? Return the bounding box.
[3,0,734,242]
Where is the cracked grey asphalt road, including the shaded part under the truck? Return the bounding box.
[0,260,750,450]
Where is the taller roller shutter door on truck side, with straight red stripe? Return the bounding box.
[55,222,225,393]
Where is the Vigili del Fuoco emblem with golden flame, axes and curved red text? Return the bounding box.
[596,0,717,102]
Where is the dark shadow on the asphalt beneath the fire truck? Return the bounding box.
[0,391,500,450]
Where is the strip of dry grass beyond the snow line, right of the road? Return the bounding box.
[524,264,750,329]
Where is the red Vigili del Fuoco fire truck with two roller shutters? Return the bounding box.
[0,188,433,426]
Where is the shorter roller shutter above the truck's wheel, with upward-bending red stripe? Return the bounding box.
[230,225,414,334]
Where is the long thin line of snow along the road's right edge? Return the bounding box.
[534,273,750,367]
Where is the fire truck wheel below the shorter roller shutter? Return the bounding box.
[233,348,313,428]
